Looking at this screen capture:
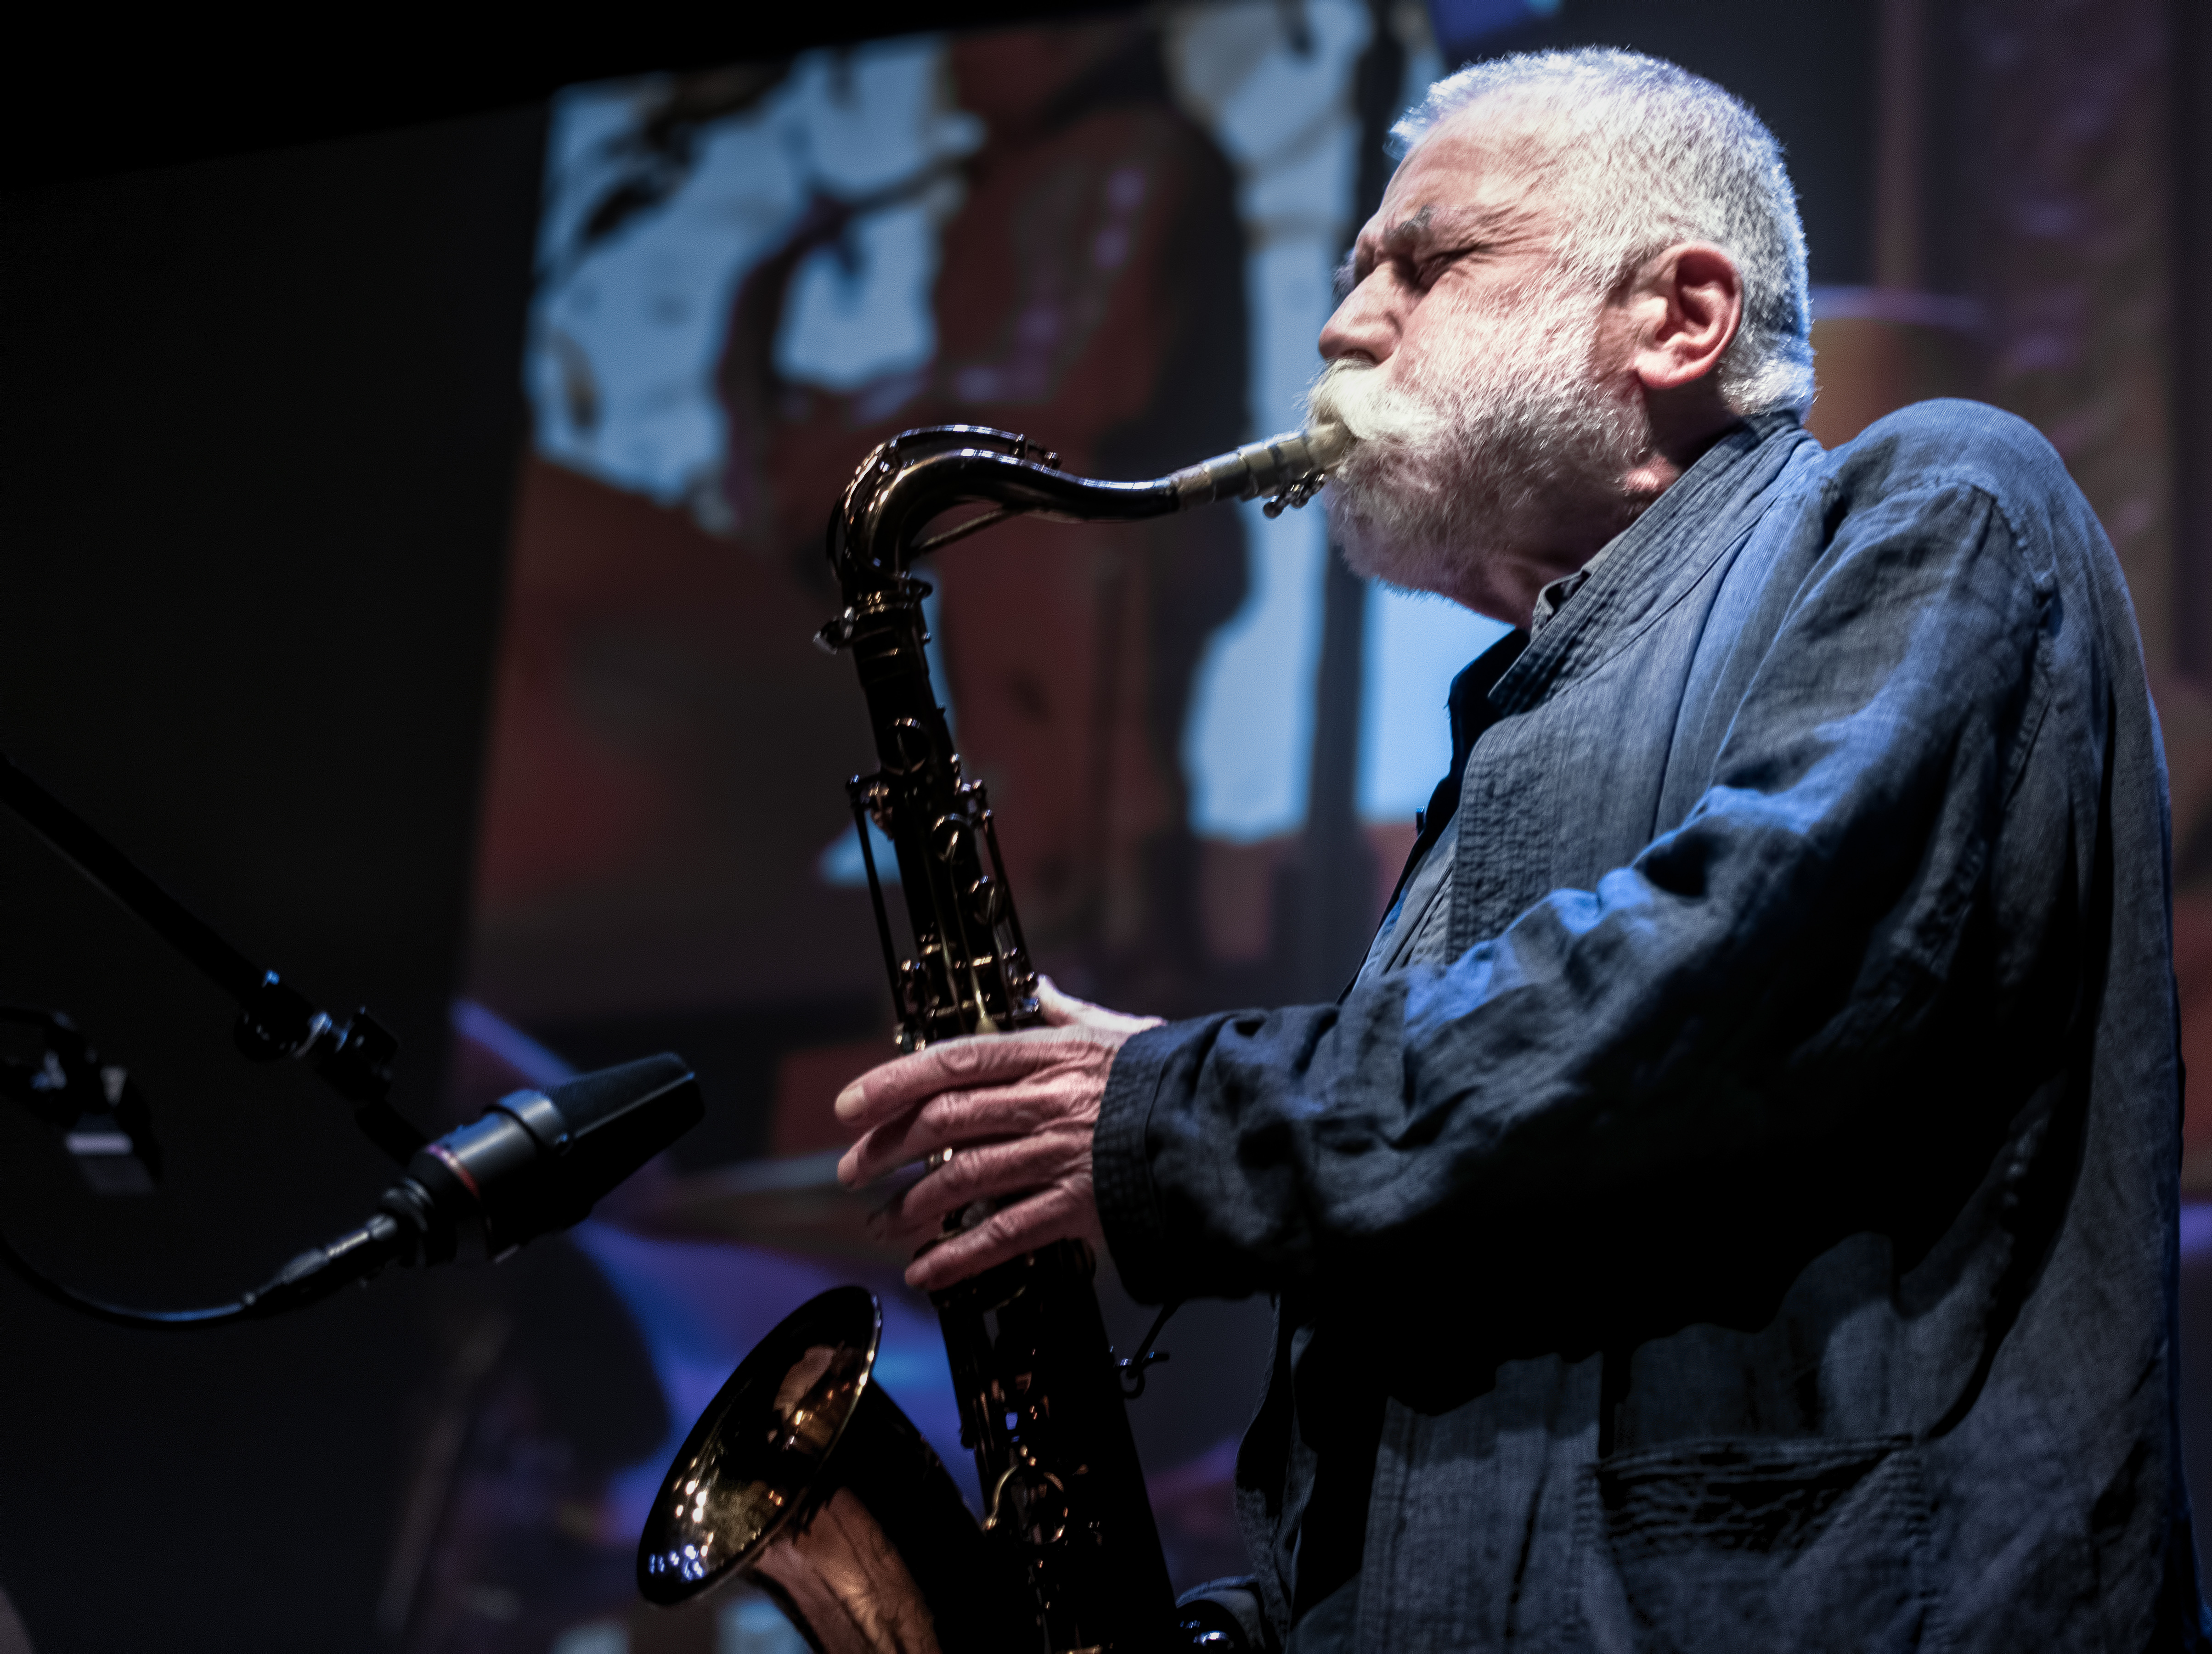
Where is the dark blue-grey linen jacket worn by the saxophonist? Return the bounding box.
[1095,402,2207,1654]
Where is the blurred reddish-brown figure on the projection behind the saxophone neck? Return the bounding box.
[719,22,1245,1004]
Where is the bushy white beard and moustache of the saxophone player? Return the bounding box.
[1307,283,1648,597]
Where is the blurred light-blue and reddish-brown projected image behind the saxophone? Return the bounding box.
[478,5,1495,1061]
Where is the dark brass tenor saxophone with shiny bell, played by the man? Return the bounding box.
[637,425,1347,1654]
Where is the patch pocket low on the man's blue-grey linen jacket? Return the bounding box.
[1575,1437,1938,1654]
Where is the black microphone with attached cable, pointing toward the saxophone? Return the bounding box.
[99,1052,705,1327]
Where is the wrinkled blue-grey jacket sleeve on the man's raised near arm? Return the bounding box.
[1095,482,2053,1300]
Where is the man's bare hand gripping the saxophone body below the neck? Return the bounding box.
[836,977,1159,1291]
